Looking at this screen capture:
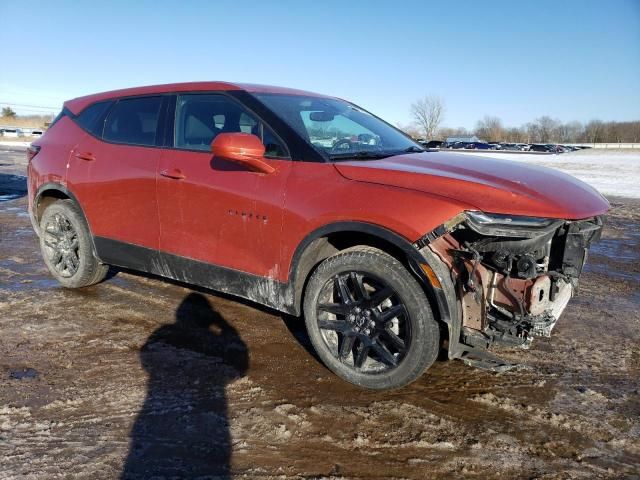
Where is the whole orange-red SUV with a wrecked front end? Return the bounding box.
[28,82,608,389]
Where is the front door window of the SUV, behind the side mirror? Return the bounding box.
[174,94,289,158]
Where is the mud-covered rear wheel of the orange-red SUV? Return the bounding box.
[40,200,109,288]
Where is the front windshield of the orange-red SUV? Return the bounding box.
[254,93,424,160]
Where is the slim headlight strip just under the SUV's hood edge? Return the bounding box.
[465,211,564,238]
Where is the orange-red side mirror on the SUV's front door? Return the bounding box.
[211,132,276,173]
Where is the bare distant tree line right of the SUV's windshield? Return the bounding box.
[398,95,640,144]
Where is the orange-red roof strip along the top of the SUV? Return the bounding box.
[64,81,333,114]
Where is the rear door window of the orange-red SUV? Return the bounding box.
[103,97,162,146]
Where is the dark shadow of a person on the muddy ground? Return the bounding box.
[121,293,248,479]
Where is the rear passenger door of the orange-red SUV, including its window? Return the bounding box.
[67,96,165,250]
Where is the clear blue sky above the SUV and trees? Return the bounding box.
[0,0,640,128]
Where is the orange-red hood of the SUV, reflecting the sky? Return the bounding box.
[334,152,609,220]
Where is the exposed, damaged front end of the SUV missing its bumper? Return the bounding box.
[416,211,603,366]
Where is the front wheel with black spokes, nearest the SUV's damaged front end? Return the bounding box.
[304,247,440,390]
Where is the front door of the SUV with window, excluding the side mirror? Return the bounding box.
[158,93,291,278]
